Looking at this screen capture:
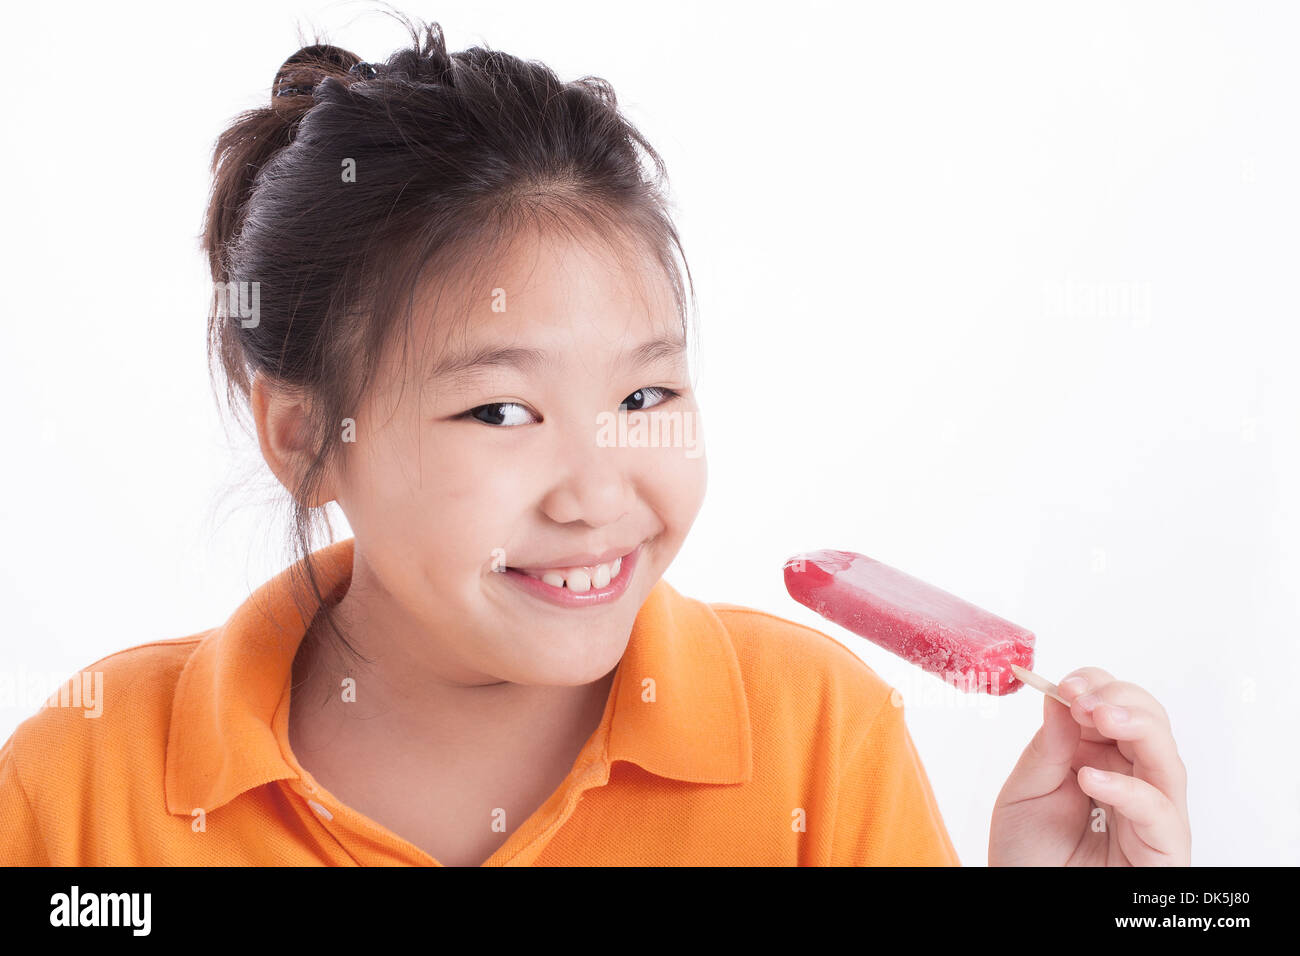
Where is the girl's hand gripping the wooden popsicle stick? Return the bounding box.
[988,667,1192,866]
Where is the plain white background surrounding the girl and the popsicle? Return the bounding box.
[0,0,1300,865]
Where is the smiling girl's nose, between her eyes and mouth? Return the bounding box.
[542,421,636,528]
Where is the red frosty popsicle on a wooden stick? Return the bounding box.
[784,550,1065,704]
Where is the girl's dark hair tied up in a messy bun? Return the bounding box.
[203,16,696,658]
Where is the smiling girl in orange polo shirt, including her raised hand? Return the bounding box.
[0,14,1191,865]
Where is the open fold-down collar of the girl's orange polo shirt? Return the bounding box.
[165,538,753,816]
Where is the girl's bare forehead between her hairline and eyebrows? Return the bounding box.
[416,223,685,380]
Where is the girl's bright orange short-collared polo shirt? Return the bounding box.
[0,538,959,866]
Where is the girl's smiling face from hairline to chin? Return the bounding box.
[332,227,707,685]
